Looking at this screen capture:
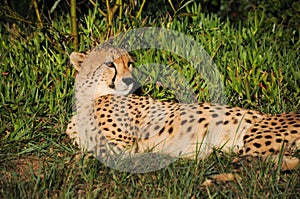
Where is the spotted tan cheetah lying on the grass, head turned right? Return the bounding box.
[66,45,300,179]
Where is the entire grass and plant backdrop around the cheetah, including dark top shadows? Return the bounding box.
[0,0,300,198]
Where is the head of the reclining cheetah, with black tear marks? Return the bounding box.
[70,46,135,97]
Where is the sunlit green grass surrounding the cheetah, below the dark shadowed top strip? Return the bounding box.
[0,3,300,198]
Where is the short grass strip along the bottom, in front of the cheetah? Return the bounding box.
[1,154,300,198]
